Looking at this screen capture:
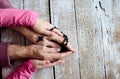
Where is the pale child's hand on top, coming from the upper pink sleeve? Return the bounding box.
[33,19,74,52]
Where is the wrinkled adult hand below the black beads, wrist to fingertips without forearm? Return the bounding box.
[29,45,72,62]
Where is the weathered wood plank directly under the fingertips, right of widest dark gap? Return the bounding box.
[50,0,80,79]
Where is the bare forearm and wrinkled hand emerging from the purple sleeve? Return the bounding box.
[8,45,72,62]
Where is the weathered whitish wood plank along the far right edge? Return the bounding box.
[100,0,120,79]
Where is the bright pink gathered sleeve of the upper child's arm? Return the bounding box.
[0,8,38,27]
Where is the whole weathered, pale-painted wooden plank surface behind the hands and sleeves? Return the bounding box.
[1,0,120,79]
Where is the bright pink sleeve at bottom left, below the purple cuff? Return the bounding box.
[6,60,35,79]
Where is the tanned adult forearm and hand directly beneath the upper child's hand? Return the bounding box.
[12,27,60,48]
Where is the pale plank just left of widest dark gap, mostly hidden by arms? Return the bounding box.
[24,0,54,79]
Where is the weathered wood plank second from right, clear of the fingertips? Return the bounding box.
[75,0,105,79]
